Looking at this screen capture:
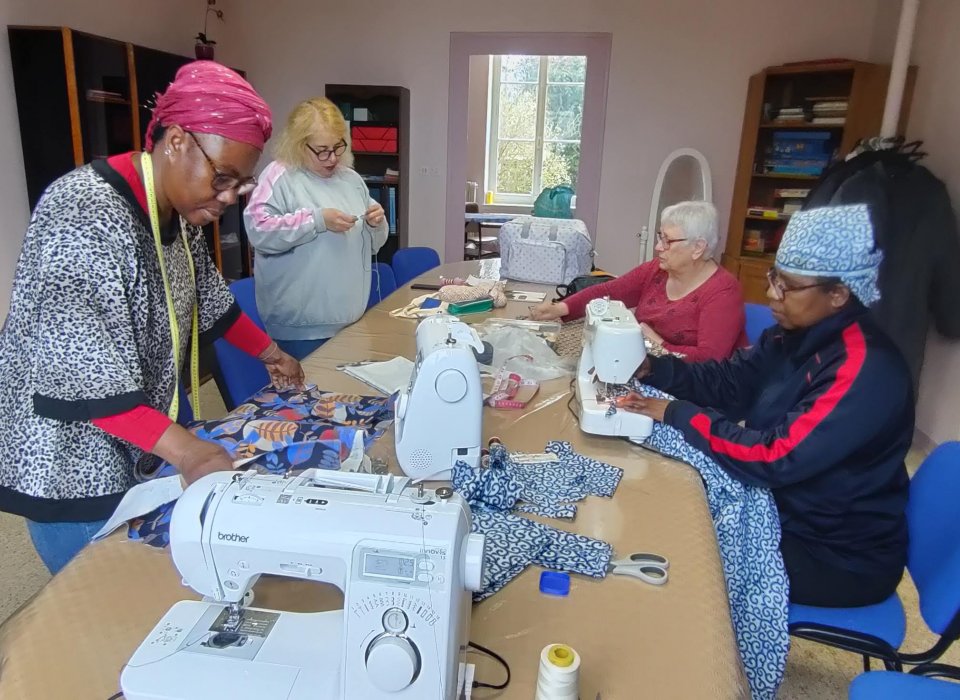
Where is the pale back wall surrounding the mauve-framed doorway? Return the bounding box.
[214,0,888,272]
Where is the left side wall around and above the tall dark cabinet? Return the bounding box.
[0,0,202,319]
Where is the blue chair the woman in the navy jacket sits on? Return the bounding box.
[789,442,960,671]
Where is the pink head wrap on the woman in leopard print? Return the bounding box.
[147,61,273,151]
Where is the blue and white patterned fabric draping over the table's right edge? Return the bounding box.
[624,382,790,700]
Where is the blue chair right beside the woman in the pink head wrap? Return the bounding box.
[213,277,270,411]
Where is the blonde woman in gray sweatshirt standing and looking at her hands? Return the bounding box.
[244,97,387,359]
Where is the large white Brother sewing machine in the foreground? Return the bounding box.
[120,470,484,700]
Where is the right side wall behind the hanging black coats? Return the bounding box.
[904,0,960,443]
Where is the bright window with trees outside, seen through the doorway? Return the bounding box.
[486,56,587,204]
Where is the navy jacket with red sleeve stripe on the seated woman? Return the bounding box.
[644,302,914,573]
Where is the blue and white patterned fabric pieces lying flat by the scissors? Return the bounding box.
[453,442,623,601]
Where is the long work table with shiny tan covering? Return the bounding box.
[0,260,749,700]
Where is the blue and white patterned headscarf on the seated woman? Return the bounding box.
[776,204,883,306]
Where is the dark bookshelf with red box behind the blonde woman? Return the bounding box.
[325,85,410,264]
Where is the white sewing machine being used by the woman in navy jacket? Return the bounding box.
[576,298,653,441]
